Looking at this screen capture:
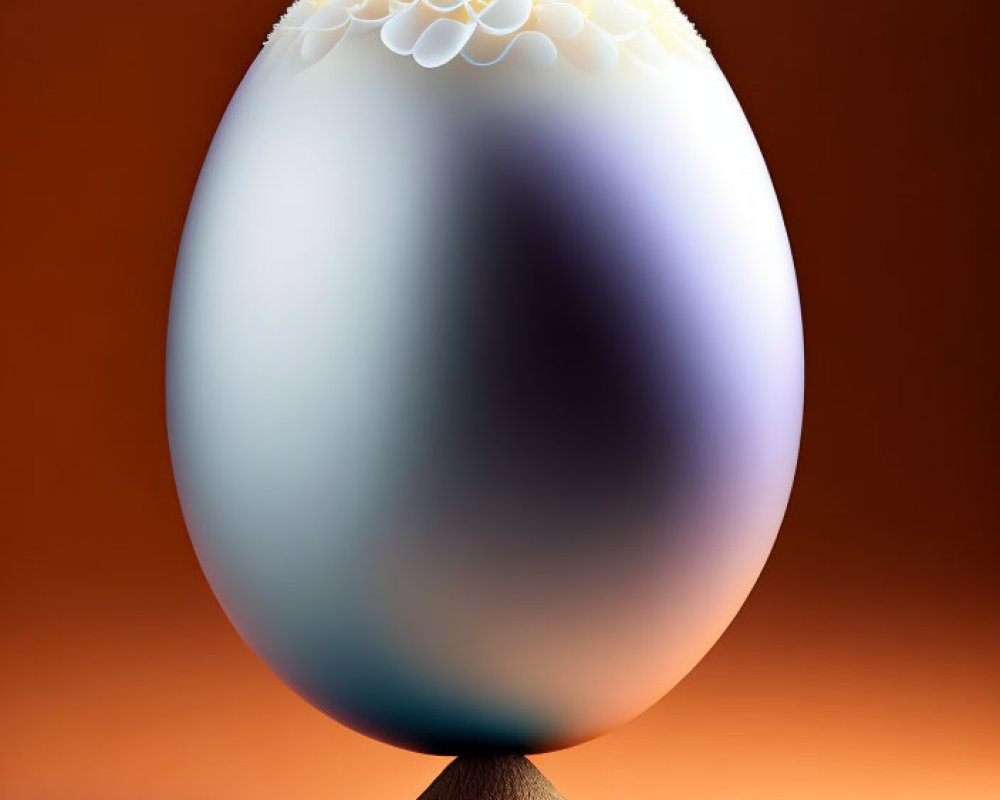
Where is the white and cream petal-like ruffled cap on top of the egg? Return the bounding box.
[267,0,711,72]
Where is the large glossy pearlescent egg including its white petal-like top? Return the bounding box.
[166,0,803,754]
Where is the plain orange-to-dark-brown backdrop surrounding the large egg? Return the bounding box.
[0,0,1000,800]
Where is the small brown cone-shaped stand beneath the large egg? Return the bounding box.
[417,756,565,800]
